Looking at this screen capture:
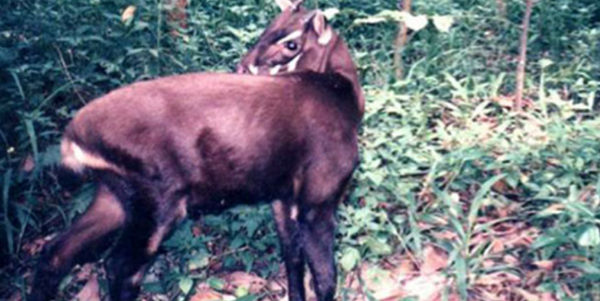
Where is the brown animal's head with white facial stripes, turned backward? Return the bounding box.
[237,0,337,75]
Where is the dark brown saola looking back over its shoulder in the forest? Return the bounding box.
[28,3,363,301]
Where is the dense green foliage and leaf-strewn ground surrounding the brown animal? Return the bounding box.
[0,0,600,301]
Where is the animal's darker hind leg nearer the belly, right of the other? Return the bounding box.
[107,193,186,301]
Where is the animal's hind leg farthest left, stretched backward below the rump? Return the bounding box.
[27,184,125,300]
